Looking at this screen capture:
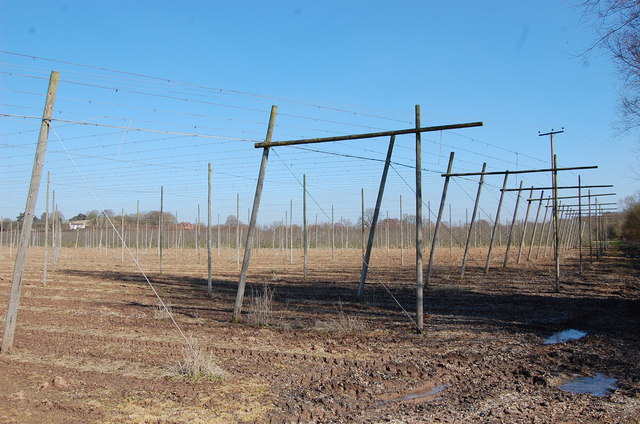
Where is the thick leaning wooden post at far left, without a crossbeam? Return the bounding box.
[1,71,60,353]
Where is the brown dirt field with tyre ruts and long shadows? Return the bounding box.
[0,243,640,423]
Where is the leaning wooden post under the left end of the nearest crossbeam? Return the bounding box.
[232,105,278,322]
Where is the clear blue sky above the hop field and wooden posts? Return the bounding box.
[0,0,640,224]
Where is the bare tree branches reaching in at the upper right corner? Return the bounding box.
[580,0,640,131]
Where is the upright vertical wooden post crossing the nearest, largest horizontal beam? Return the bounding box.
[415,105,424,333]
